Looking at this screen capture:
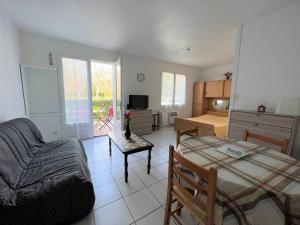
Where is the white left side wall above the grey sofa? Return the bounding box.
[0,15,25,122]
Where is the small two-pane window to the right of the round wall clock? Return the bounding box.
[161,72,186,106]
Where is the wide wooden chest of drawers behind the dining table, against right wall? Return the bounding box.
[228,110,300,160]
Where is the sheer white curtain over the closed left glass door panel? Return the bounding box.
[62,58,93,139]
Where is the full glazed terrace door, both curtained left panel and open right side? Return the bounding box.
[61,57,124,139]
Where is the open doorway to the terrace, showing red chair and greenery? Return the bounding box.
[91,60,122,136]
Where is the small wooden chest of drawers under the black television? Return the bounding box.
[130,110,153,135]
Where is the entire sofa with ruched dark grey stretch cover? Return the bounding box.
[0,118,95,225]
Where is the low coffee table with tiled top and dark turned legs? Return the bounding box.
[108,131,154,183]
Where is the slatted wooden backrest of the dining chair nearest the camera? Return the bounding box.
[168,146,217,225]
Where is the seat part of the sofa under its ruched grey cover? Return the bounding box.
[17,139,90,188]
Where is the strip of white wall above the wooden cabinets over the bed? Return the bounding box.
[200,64,233,81]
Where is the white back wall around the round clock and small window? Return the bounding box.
[122,55,199,124]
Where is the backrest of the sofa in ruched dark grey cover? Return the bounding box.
[0,118,44,186]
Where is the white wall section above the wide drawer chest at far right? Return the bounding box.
[234,2,300,111]
